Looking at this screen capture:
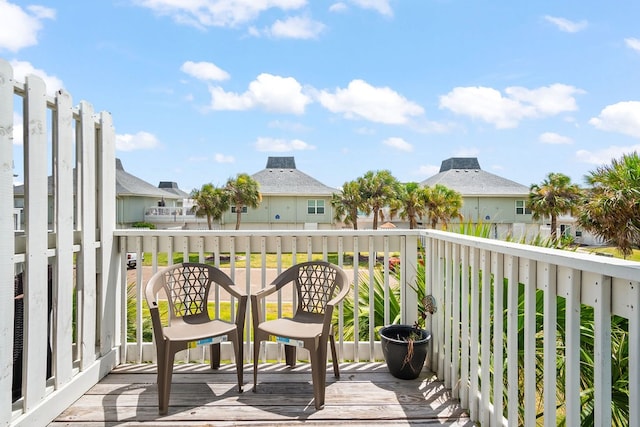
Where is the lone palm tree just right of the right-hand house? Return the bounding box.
[529,172,582,242]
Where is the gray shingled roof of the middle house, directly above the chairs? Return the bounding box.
[252,157,338,196]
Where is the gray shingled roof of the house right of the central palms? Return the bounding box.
[420,157,529,197]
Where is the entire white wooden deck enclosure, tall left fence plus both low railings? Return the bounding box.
[0,59,640,426]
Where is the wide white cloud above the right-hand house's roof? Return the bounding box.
[440,84,584,129]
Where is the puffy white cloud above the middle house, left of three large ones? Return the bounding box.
[209,73,311,114]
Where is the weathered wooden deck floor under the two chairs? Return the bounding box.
[50,363,475,427]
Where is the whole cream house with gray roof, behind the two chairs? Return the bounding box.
[215,157,339,230]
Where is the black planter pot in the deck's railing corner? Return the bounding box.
[380,325,431,380]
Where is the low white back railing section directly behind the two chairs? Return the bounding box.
[116,229,418,363]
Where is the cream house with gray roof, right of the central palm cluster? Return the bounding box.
[420,157,540,239]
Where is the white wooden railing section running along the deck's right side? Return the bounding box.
[421,231,640,427]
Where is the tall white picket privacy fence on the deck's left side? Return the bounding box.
[0,59,119,426]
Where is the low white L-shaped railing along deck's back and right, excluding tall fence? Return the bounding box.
[116,230,640,426]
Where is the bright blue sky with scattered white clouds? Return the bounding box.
[0,0,640,191]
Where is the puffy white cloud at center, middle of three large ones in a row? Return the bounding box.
[318,80,424,125]
